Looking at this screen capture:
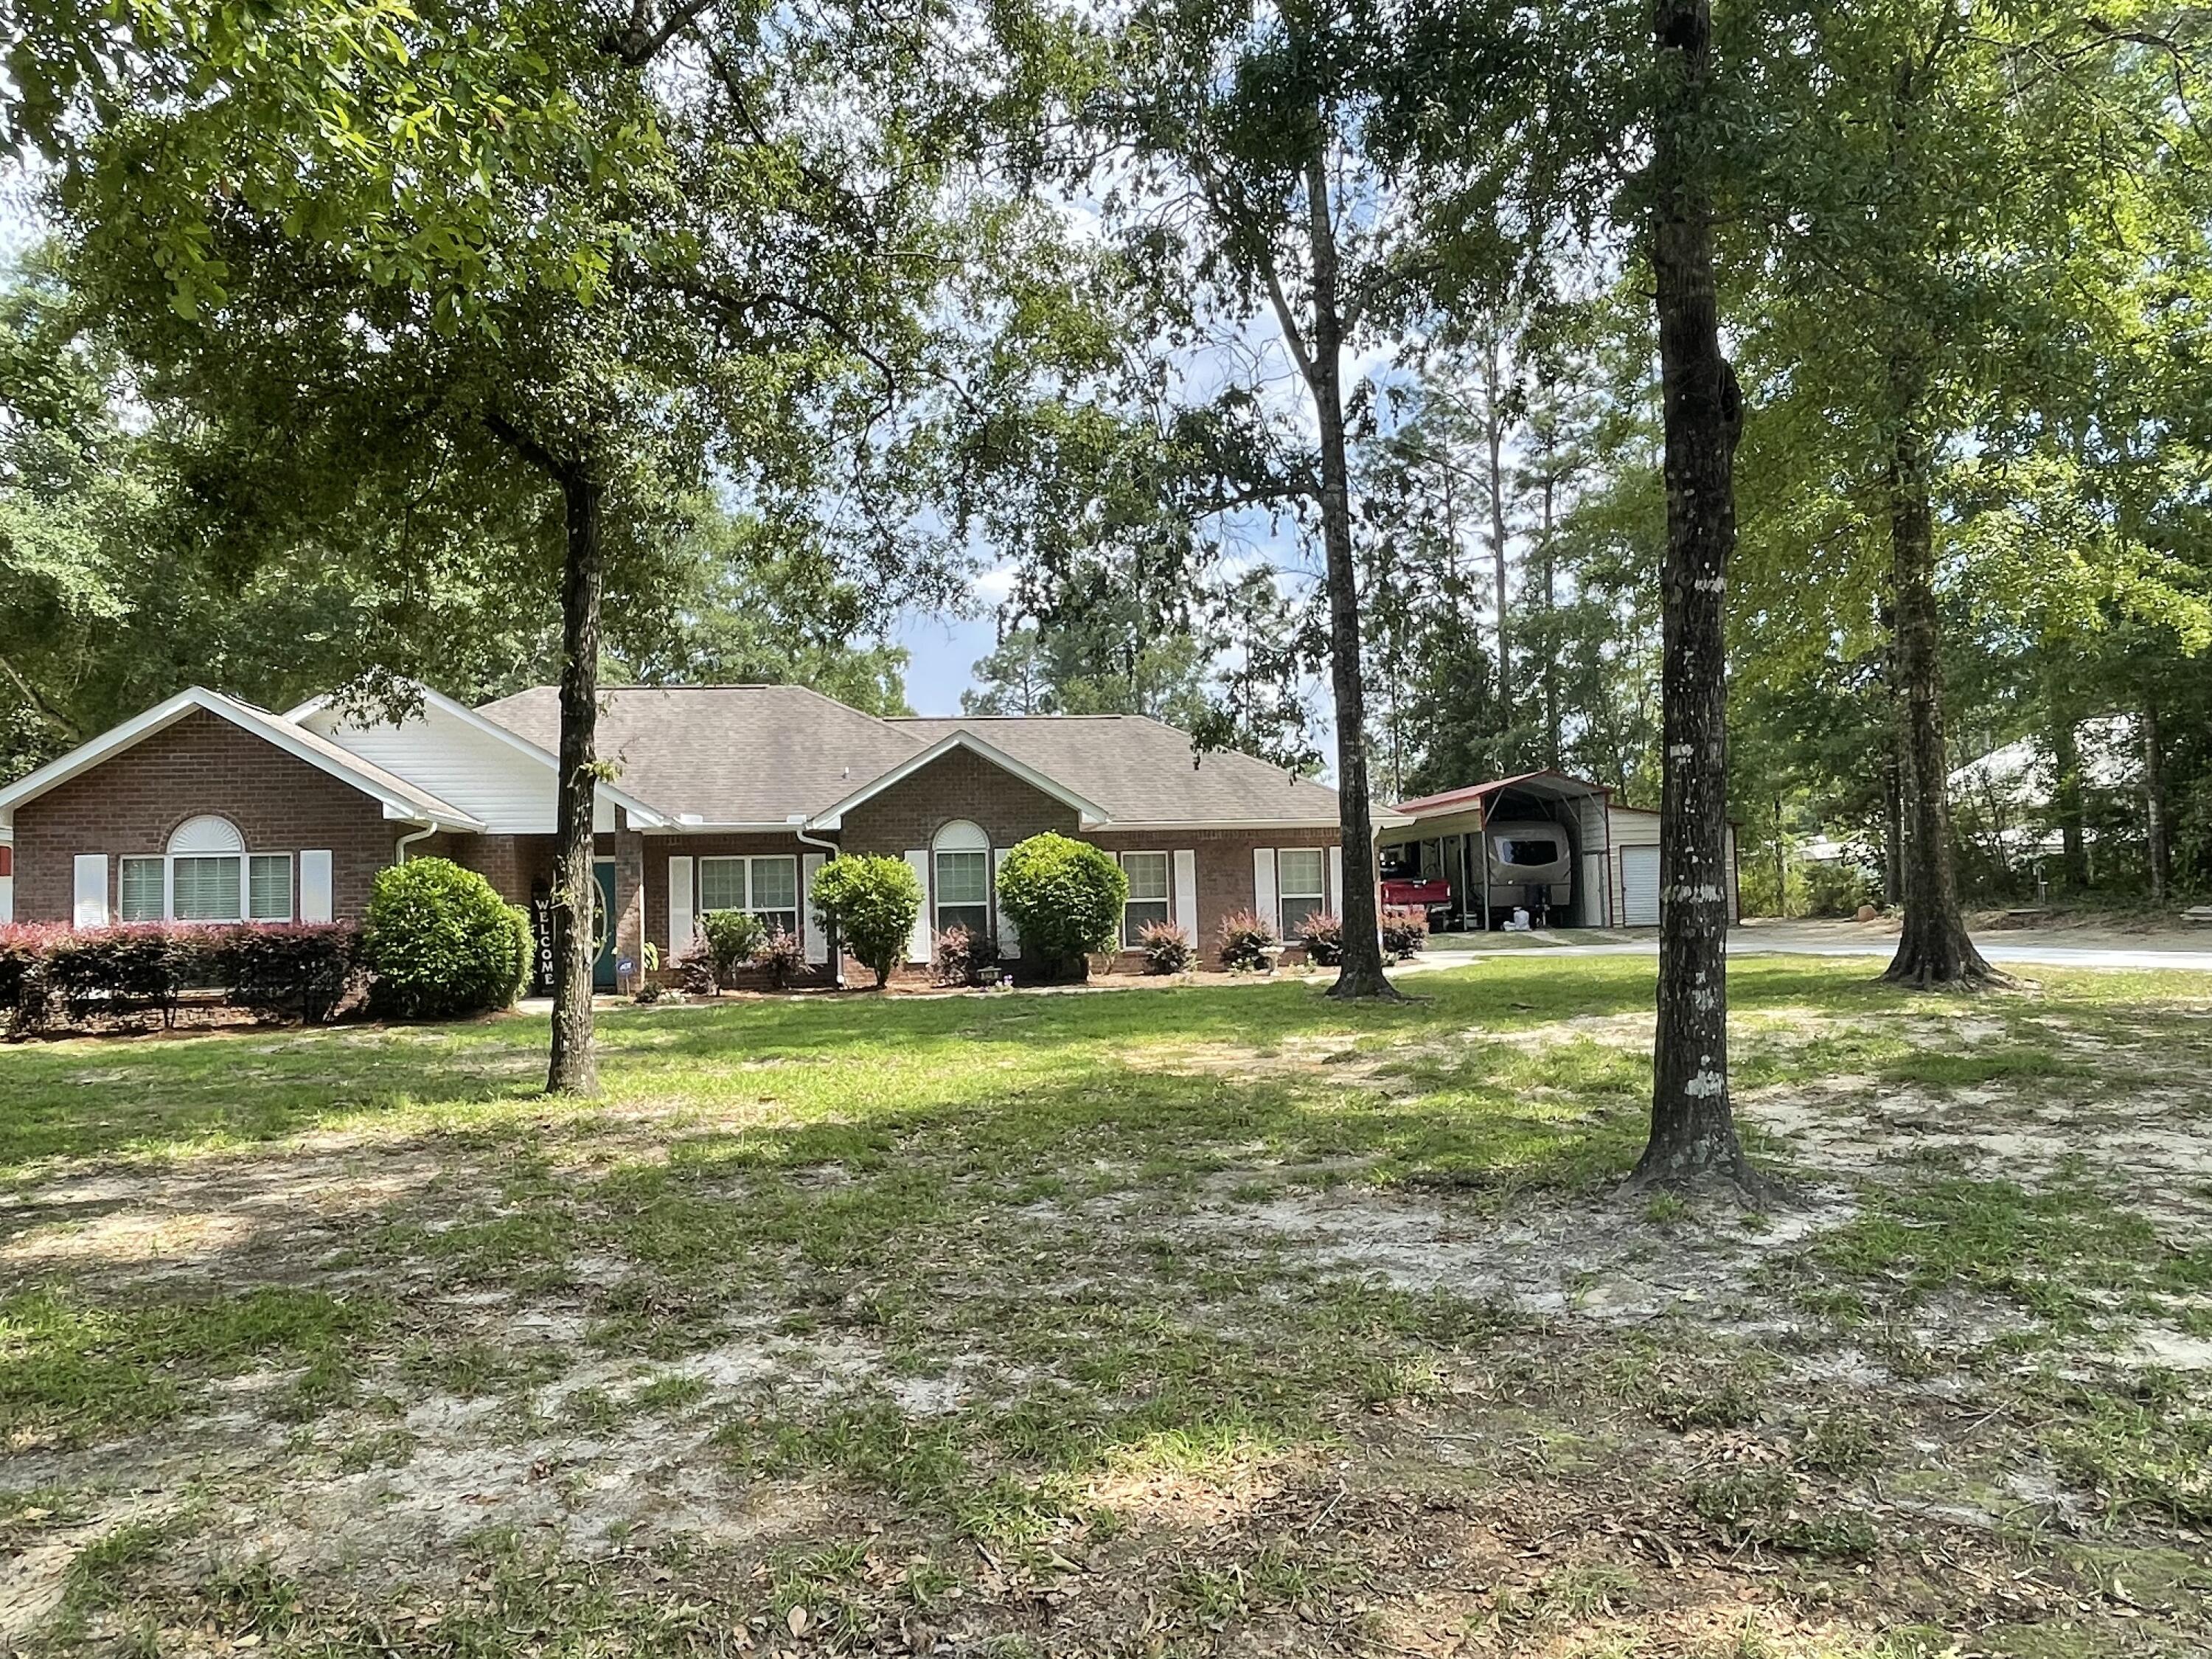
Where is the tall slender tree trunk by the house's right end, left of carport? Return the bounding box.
[1305,146,1398,1000]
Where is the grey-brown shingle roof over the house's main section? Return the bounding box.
[478,686,1336,827]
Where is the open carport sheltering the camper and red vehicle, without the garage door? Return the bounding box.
[1380,772,1613,931]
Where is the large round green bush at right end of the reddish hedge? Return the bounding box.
[361,858,531,1020]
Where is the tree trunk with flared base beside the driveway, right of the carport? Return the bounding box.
[1885,376,1993,989]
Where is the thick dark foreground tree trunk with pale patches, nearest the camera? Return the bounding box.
[1632,0,1765,1194]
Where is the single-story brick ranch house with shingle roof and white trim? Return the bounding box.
[0,686,1394,989]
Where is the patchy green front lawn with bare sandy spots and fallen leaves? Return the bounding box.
[0,956,2212,1659]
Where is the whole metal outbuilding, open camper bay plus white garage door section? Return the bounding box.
[1380,772,1743,929]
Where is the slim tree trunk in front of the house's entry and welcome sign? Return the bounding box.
[546,467,604,1095]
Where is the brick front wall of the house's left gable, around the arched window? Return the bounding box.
[15,710,407,922]
